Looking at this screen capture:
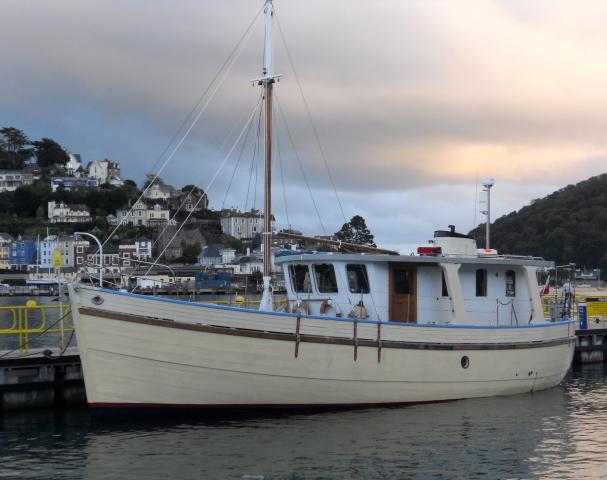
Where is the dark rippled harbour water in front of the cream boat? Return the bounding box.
[0,365,607,480]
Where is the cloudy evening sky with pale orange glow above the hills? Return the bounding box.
[0,0,607,249]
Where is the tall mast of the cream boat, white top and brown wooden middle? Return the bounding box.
[258,0,280,311]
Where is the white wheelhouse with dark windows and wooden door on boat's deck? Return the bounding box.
[276,231,552,326]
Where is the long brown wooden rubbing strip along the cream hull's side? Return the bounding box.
[78,307,575,350]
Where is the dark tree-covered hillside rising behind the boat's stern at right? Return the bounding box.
[470,174,607,272]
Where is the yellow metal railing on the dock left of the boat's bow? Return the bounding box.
[0,300,74,355]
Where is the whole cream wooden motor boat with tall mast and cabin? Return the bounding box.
[69,0,575,410]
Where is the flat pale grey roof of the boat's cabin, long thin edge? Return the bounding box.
[274,253,554,267]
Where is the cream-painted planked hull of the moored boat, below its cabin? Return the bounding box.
[70,287,574,408]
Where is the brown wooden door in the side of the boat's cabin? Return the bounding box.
[390,264,417,323]
